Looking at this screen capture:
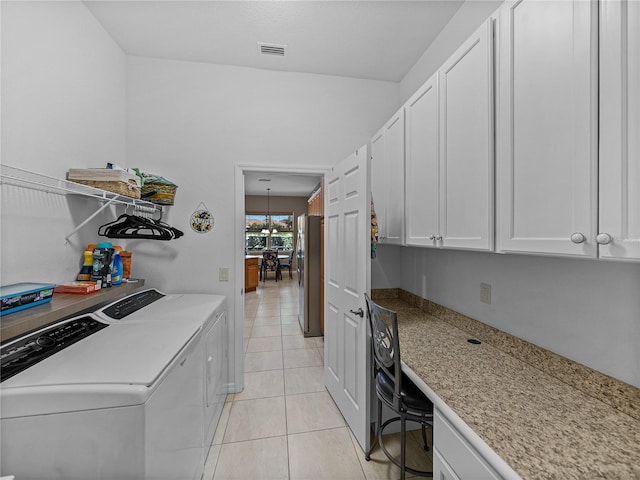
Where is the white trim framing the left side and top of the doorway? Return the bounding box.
[229,164,331,393]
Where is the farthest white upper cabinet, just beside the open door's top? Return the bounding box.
[371,108,404,245]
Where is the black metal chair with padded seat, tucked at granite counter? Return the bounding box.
[365,294,433,480]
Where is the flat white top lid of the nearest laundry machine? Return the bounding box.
[2,318,202,389]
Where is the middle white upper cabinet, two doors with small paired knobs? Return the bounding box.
[405,20,494,250]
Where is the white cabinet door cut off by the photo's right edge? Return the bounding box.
[598,0,640,260]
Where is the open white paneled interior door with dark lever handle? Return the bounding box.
[324,146,371,450]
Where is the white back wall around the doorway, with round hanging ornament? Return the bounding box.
[127,57,398,295]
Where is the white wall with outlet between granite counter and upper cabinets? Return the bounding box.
[400,248,640,386]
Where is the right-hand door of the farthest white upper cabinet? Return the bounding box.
[384,108,404,245]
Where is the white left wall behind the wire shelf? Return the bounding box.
[1,1,126,285]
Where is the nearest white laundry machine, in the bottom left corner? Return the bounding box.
[0,315,204,480]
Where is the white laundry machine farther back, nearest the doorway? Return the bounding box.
[94,289,229,448]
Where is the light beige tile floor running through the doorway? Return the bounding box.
[203,274,431,480]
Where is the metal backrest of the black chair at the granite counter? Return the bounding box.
[364,293,402,409]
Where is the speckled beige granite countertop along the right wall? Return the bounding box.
[372,291,640,480]
